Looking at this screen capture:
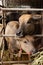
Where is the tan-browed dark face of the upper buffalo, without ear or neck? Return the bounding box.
[17,14,34,36]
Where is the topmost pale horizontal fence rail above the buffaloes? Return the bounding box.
[1,8,43,11]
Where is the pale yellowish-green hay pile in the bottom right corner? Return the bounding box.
[31,51,43,65]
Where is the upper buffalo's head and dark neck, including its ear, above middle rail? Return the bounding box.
[17,14,41,37]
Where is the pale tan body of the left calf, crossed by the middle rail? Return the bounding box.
[5,21,19,58]
